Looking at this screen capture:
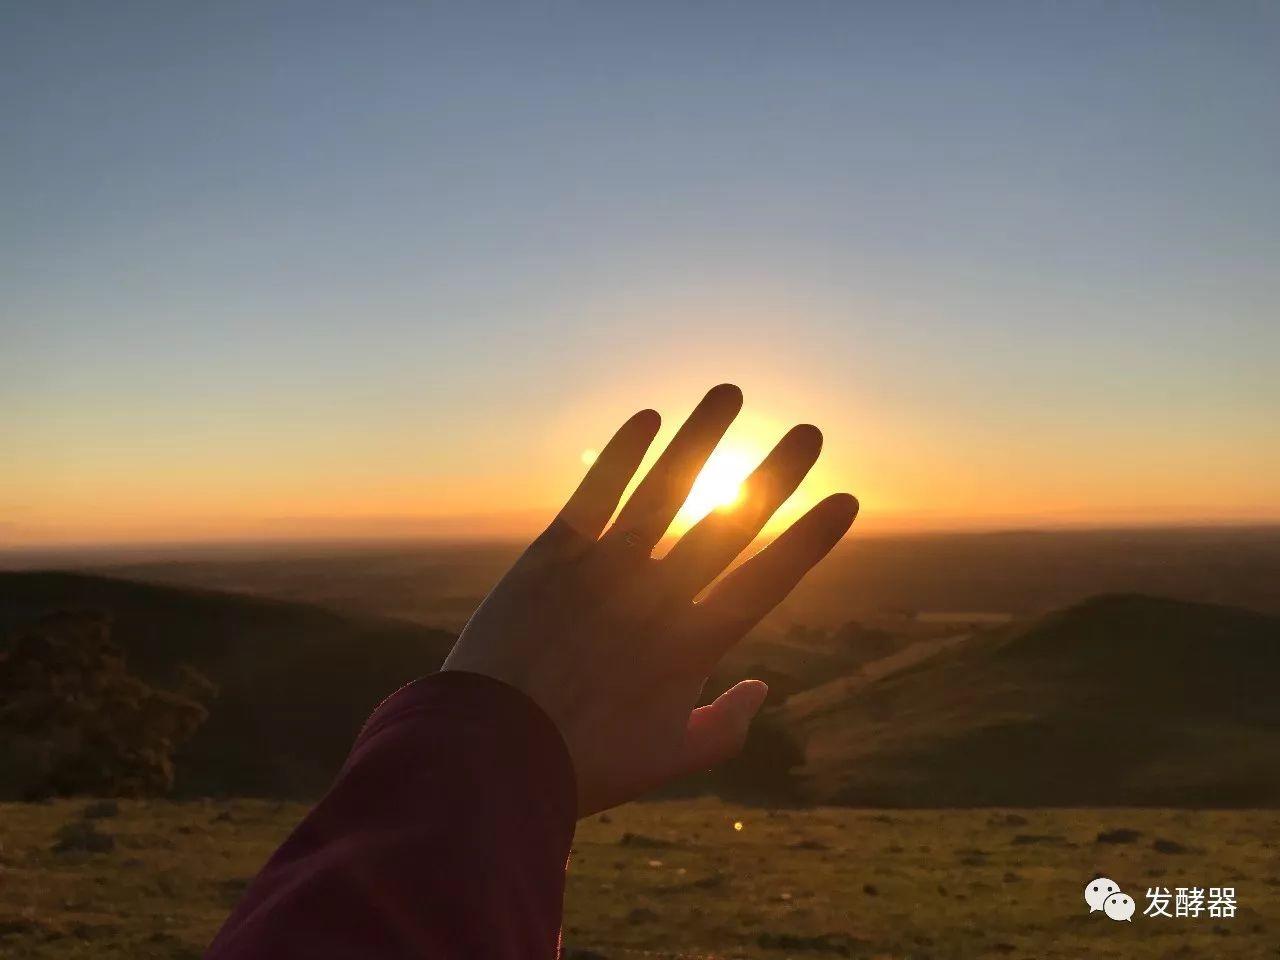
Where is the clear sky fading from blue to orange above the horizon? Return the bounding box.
[0,0,1280,547]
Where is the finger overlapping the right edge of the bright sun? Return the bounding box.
[662,424,822,598]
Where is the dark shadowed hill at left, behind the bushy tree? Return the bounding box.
[0,572,453,797]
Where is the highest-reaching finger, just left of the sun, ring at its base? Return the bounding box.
[604,383,742,552]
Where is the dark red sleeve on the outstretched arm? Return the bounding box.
[205,672,577,960]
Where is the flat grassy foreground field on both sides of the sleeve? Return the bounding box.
[0,800,1280,960]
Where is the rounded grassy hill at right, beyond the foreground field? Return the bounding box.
[776,595,1280,806]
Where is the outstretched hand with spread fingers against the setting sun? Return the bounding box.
[443,384,858,817]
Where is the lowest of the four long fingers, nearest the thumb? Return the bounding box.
[691,493,858,666]
